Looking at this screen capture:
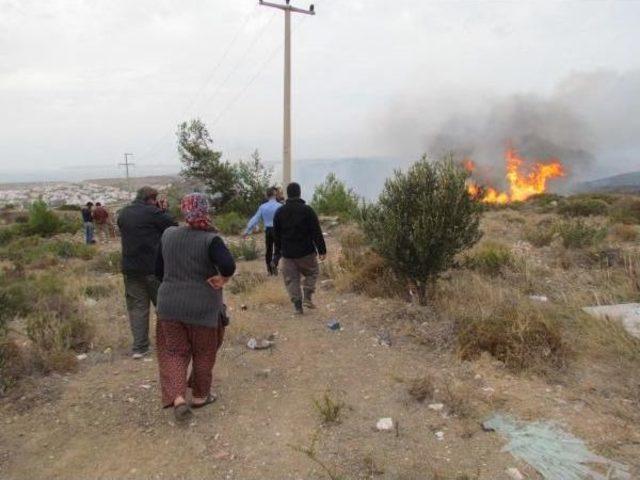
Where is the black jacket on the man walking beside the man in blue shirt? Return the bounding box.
[273,198,327,258]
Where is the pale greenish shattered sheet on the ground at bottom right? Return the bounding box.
[483,414,631,480]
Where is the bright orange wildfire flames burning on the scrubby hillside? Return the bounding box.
[464,148,564,204]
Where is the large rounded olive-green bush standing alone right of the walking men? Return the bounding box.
[362,156,482,303]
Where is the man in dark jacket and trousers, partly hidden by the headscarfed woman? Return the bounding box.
[118,187,177,359]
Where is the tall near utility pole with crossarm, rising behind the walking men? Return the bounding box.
[259,0,316,187]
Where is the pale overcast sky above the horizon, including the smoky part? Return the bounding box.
[0,0,640,181]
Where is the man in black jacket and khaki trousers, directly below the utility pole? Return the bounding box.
[273,183,327,314]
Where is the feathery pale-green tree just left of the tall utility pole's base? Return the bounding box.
[226,150,273,215]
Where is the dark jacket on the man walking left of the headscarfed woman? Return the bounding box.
[118,200,177,275]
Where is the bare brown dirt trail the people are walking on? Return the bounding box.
[0,256,636,480]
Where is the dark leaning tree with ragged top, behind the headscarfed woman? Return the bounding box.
[176,119,237,206]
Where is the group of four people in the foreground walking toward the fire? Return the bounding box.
[118,183,326,421]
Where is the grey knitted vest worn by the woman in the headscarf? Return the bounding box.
[157,227,223,327]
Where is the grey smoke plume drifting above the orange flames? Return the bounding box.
[378,71,640,189]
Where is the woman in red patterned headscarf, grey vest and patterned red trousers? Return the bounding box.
[156,193,235,421]
